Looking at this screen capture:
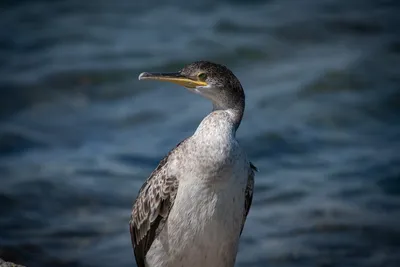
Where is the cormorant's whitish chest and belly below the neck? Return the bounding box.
[147,134,248,267]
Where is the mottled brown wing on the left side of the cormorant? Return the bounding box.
[129,142,182,267]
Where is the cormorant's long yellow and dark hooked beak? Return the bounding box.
[139,72,207,89]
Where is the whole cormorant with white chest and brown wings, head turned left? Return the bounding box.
[129,61,258,267]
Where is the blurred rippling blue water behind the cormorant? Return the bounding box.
[0,0,400,267]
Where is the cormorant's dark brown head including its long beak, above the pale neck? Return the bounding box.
[139,61,244,109]
